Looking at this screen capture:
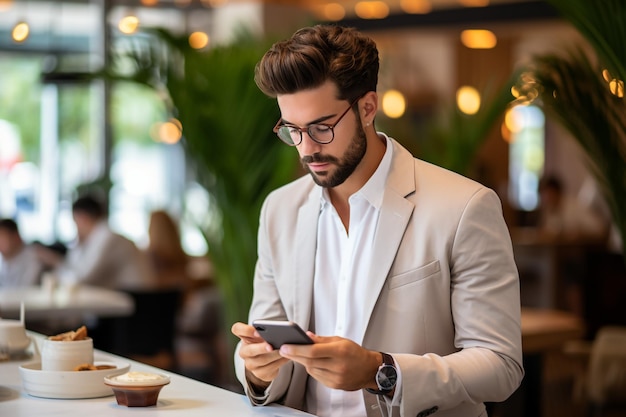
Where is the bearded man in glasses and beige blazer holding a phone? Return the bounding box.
[232,25,523,417]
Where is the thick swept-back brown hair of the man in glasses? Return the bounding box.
[254,25,379,101]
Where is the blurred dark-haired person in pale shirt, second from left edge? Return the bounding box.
[40,195,155,290]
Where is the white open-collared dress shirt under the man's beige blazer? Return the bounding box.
[307,135,399,417]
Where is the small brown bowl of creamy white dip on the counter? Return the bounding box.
[104,372,170,407]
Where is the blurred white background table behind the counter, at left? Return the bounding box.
[0,285,135,320]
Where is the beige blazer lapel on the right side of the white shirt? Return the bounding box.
[360,139,415,342]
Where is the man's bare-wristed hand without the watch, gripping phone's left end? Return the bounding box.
[231,323,289,391]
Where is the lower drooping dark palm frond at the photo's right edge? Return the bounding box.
[520,50,626,258]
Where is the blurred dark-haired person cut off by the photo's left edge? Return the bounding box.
[0,219,44,288]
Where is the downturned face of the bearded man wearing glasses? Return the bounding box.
[278,83,367,188]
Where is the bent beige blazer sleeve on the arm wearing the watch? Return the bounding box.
[393,187,524,416]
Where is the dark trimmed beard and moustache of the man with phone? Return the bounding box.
[300,118,367,188]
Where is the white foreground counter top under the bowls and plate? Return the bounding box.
[0,334,310,417]
